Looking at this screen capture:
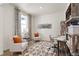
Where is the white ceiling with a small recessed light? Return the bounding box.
[15,3,67,15]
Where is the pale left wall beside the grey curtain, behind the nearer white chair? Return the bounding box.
[0,4,15,50]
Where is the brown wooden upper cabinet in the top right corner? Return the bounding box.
[65,3,79,23]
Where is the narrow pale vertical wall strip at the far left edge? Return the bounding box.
[0,6,3,55]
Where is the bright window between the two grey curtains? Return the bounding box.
[21,14,29,38]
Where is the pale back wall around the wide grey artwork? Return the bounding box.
[32,12,65,40]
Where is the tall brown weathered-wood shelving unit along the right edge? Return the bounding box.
[65,3,79,55]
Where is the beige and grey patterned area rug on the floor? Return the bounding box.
[25,41,57,56]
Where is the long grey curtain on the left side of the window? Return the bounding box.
[15,8,21,36]
